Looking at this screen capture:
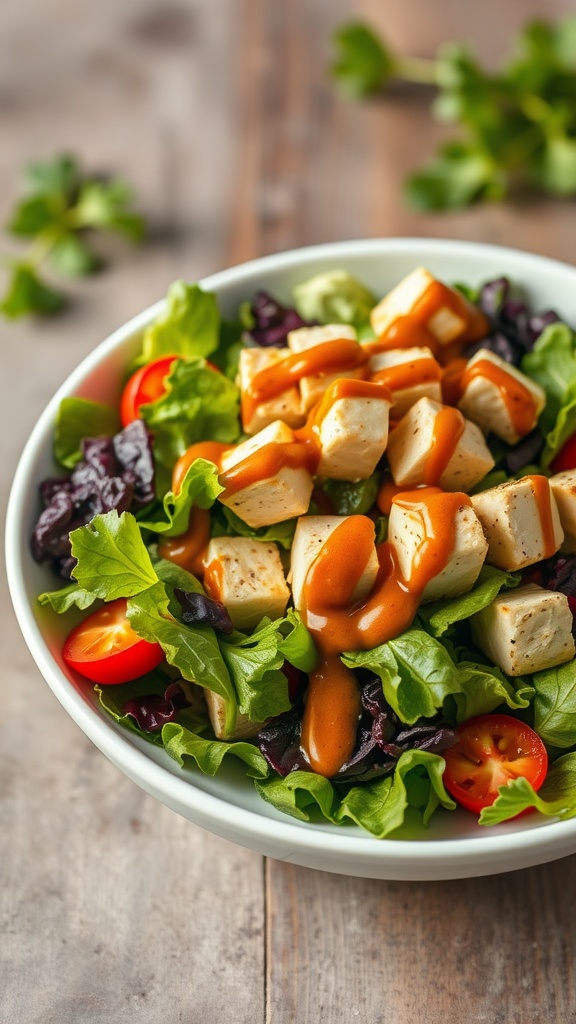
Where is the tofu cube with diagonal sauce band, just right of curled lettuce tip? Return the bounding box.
[219,420,314,528]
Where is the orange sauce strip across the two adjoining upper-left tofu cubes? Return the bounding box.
[242,338,369,422]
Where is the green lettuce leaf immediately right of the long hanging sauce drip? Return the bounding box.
[342,629,460,725]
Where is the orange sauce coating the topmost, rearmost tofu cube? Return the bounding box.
[370,281,490,361]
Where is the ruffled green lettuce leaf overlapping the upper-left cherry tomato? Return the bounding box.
[140,359,240,470]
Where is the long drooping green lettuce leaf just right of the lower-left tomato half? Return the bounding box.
[127,581,237,734]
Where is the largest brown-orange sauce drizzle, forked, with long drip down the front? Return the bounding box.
[301,488,471,778]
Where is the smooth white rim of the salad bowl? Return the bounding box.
[5,238,576,878]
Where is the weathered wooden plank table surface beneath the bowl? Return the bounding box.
[0,0,576,1024]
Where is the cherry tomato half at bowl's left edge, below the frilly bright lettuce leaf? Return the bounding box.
[63,597,164,685]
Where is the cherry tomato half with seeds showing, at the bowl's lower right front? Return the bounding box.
[444,715,548,814]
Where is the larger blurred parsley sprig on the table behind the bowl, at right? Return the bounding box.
[331,15,576,210]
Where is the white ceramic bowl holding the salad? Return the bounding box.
[6,239,576,880]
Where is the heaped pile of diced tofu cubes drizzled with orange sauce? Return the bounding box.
[193,267,576,738]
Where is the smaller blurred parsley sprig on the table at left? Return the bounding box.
[0,155,145,319]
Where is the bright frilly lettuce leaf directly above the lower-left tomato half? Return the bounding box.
[70,510,158,601]
